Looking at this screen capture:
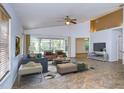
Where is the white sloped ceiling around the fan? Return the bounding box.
[12,3,120,29]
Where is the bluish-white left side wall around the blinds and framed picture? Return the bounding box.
[0,4,23,88]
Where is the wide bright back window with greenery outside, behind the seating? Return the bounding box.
[29,36,67,53]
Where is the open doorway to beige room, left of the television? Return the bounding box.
[76,38,89,59]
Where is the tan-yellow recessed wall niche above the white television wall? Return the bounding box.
[90,9,123,32]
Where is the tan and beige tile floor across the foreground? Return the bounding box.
[13,59,124,89]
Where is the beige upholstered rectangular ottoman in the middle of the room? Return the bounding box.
[57,63,78,74]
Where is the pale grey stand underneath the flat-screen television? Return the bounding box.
[88,51,108,61]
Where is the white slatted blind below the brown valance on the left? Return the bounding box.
[0,21,9,80]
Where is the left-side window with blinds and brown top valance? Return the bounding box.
[0,4,9,81]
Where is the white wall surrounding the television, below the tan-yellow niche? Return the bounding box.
[90,28,120,62]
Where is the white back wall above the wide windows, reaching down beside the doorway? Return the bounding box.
[24,21,90,57]
